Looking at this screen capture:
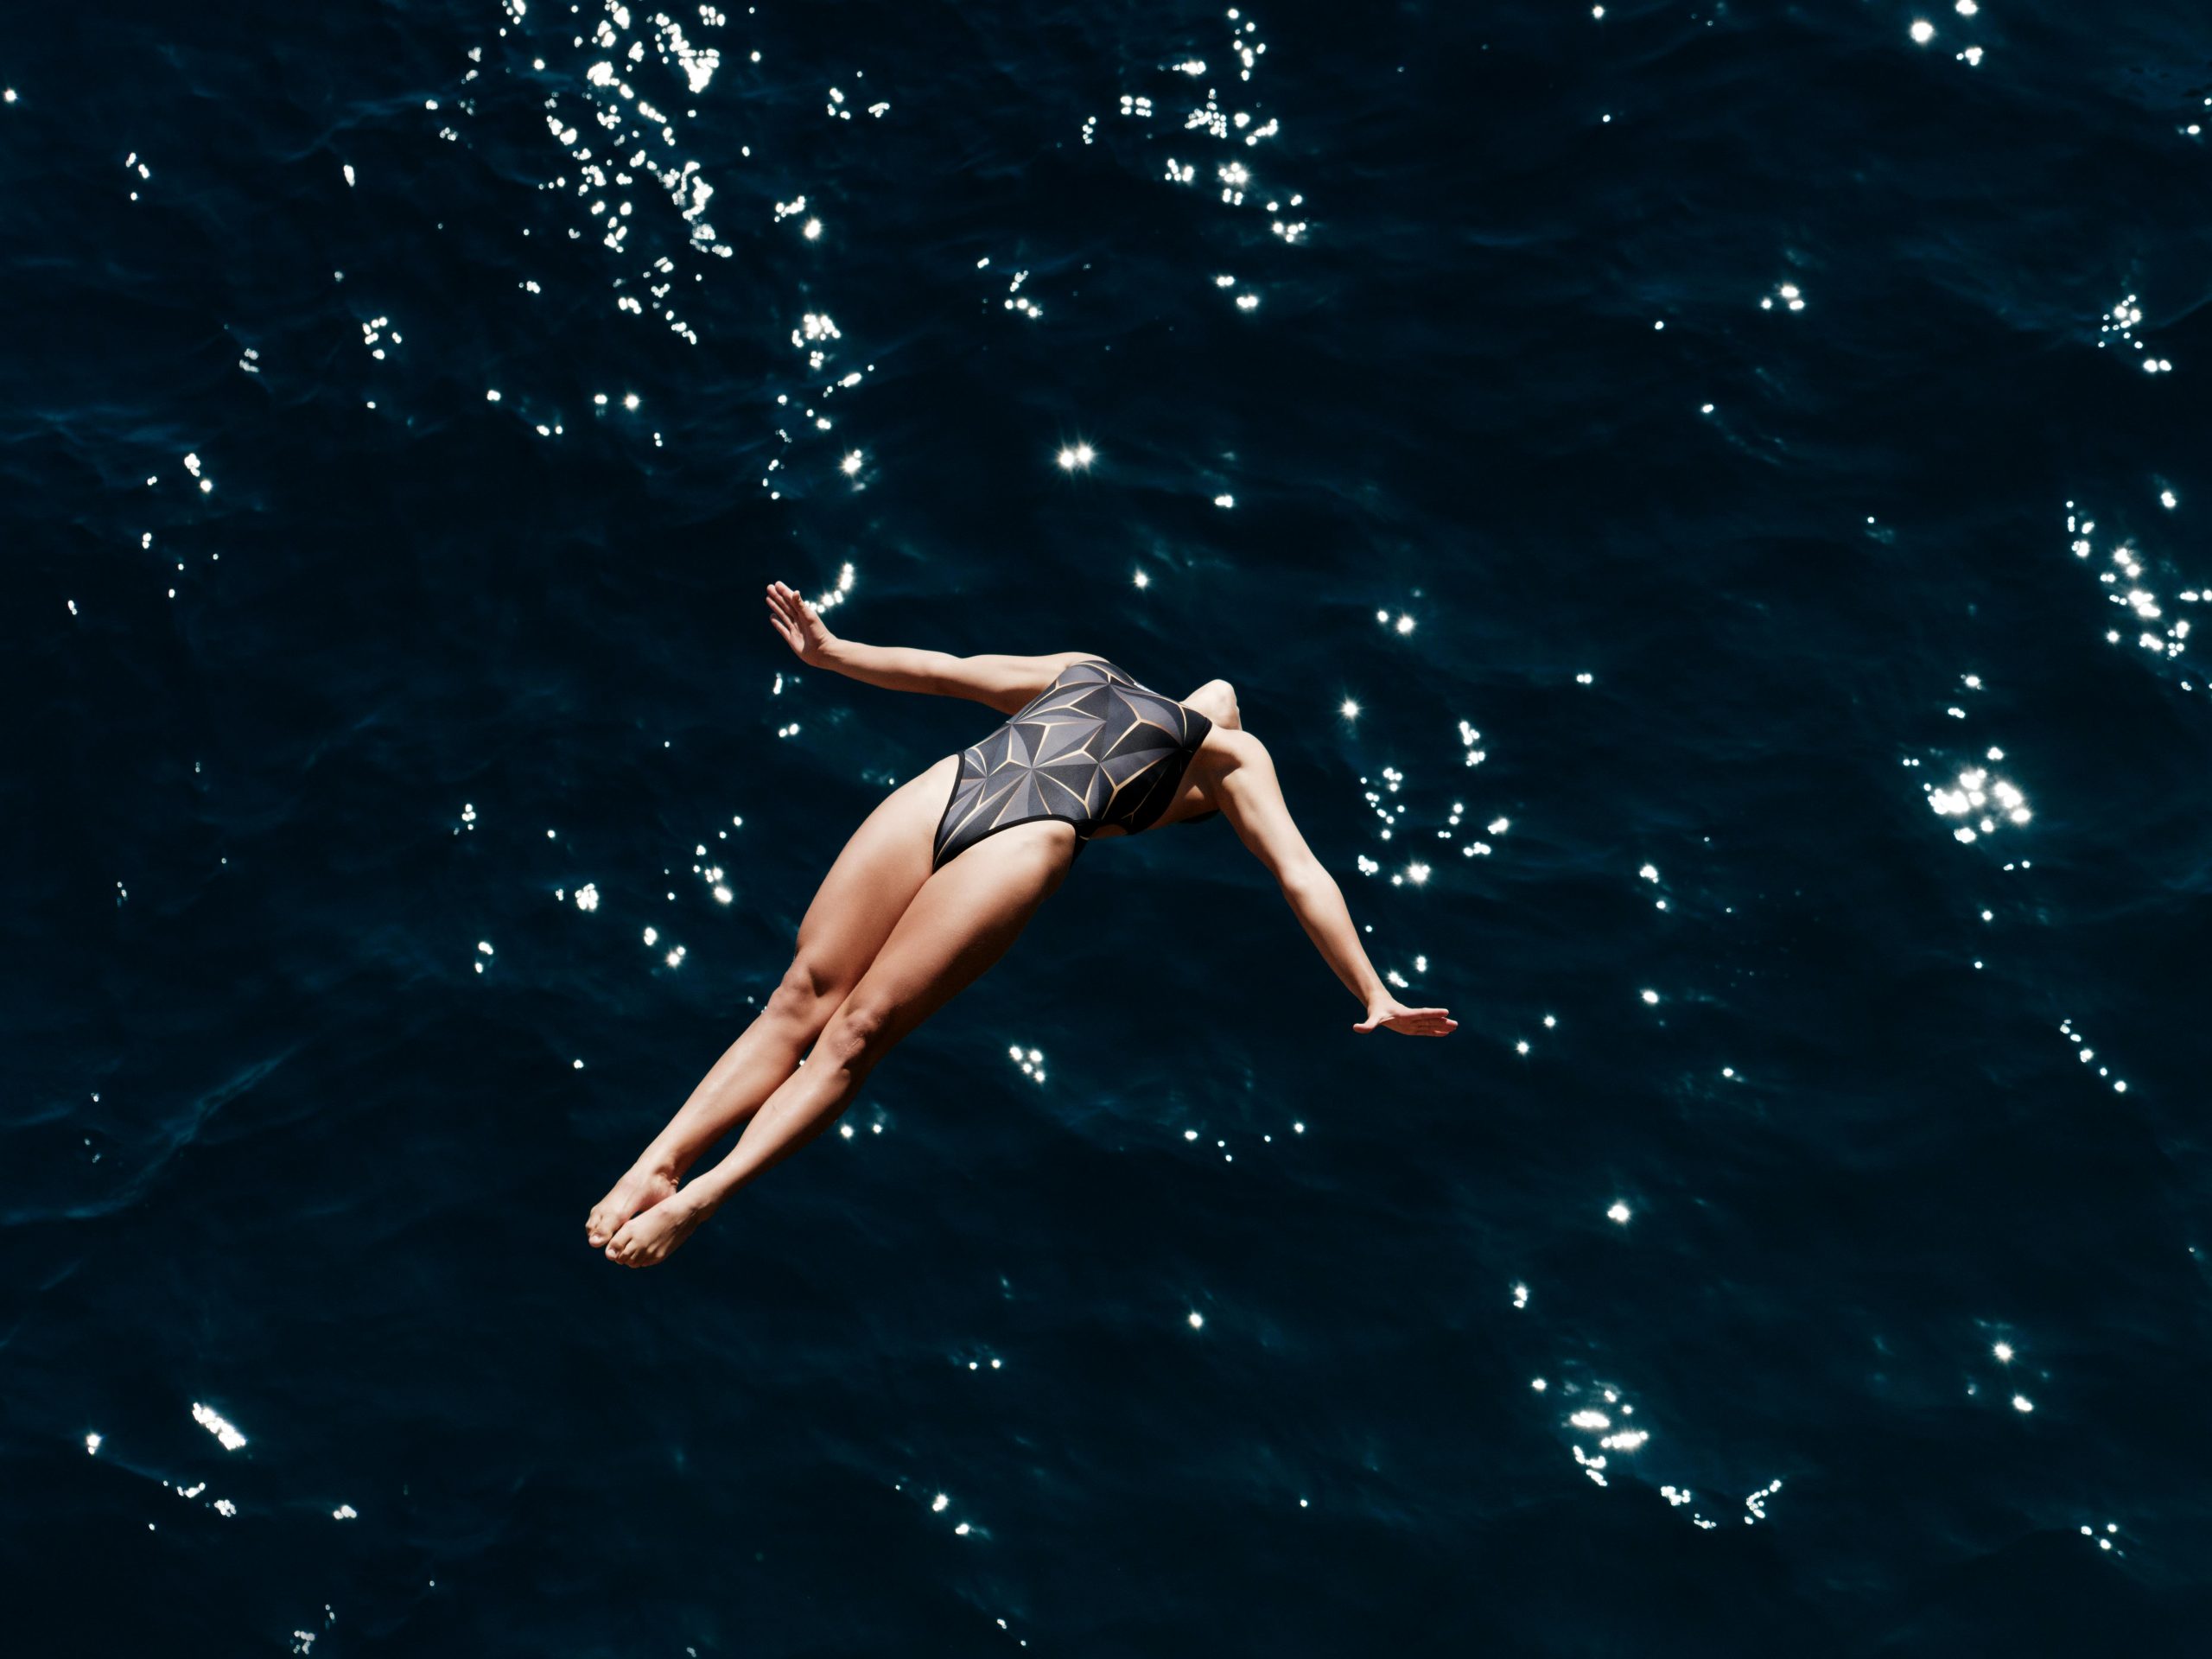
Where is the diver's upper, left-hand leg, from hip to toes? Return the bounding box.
[584,754,960,1249]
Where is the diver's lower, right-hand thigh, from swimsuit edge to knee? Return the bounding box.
[834,818,1075,1053]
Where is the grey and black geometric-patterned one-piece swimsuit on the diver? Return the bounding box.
[929,657,1214,869]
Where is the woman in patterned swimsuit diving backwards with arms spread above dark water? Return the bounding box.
[584,582,1458,1268]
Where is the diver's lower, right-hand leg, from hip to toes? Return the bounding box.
[606,821,1075,1268]
